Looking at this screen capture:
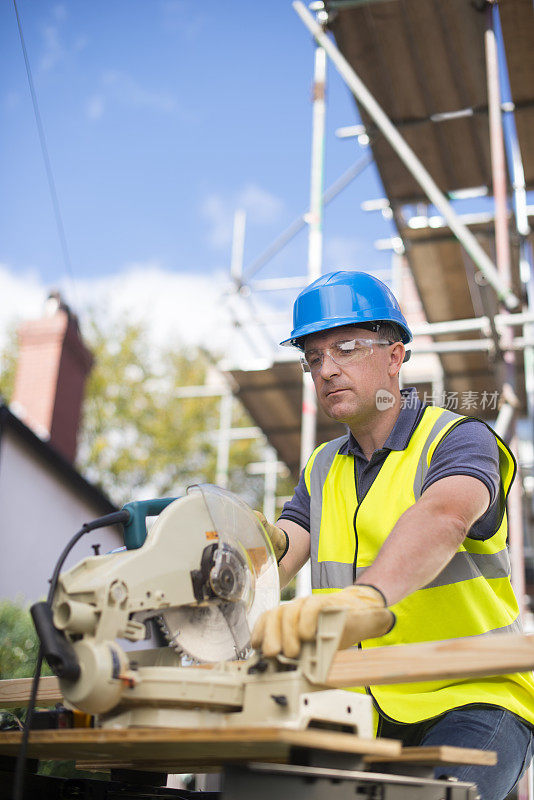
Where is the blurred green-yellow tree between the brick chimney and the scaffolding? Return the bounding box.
[78,321,259,504]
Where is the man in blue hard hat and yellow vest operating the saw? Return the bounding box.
[253,272,534,800]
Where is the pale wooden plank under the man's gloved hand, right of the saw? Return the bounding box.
[326,633,534,689]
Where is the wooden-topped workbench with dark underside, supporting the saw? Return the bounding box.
[0,712,496,800]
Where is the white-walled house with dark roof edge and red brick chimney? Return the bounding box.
[0,293,123,602]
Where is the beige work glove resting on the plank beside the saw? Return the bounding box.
[252,584,395,658]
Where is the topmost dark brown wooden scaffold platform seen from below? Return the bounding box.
[332,0,534,197]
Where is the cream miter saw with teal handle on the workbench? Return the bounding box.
[32,485,373,738]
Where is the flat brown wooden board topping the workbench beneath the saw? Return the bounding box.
[0,727,401,771]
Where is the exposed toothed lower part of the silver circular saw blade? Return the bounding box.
[161,603,250,662]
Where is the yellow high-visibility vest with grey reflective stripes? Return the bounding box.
[305,406,534,723]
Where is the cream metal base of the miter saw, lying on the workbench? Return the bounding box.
[97,662,373,738]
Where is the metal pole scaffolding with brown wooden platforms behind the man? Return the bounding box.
[177,0,534,798]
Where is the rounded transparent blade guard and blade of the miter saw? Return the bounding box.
[161,484,280,662]
